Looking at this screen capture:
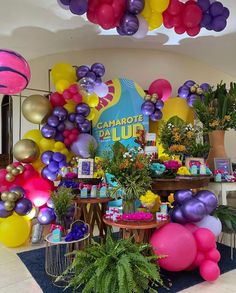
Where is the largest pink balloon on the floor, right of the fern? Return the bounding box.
[150,223,197,272]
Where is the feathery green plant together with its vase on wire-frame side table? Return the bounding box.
[51,186,75,230]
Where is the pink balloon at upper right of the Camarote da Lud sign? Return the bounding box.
[148,79,172,101]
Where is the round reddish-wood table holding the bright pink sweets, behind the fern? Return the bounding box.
[103,217,169,243]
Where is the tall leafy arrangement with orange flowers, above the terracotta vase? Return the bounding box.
[193,81,236,132]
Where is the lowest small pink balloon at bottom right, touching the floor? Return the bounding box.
[200,260,220,282]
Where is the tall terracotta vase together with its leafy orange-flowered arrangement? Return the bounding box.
[193,82,236,169]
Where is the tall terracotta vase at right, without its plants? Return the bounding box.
[206,130,227,170]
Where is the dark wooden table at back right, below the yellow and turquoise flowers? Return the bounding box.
[151,175,211,196]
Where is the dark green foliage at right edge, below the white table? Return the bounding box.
[214,205,236,233]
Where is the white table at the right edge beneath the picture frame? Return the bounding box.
[209,182,236,205]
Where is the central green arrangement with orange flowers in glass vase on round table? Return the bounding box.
[102,142,151,213]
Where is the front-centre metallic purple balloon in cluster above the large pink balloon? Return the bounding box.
[181,198,207,222]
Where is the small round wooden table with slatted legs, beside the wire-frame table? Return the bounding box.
[74,197,113,237]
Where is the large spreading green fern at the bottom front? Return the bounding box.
[58,233,163,293]
